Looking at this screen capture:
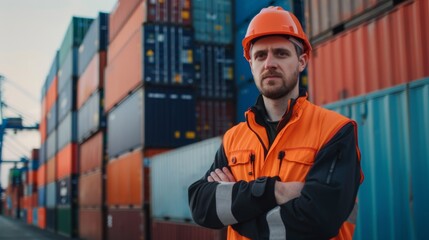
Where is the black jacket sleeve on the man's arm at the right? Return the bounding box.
[232,123,361,240]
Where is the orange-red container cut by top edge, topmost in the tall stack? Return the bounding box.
[109,0,144,43]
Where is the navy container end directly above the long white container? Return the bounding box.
[145,88,196,148]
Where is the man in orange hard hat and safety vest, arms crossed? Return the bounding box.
[189,7,363,240]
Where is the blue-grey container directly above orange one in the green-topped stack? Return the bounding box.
[57,112,77,149]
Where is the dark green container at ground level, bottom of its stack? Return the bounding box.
[56,206,78,237]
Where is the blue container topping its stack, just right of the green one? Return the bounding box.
[78,12,109,76]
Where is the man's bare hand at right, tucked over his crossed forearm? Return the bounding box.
[274,181,304,205]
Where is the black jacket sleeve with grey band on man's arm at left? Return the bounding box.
[188,145,277,228]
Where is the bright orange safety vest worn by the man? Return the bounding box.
[223,97,360,240]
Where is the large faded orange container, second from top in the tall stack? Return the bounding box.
[104,31,143,111]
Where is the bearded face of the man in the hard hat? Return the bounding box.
[250,36,308,99]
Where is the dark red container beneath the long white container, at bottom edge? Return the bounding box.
[152,220,226,240]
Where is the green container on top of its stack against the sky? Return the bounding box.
[58,17,93,68]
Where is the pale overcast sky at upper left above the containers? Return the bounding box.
[0,0,117,188]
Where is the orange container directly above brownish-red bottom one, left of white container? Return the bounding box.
[106,150,143,206]
